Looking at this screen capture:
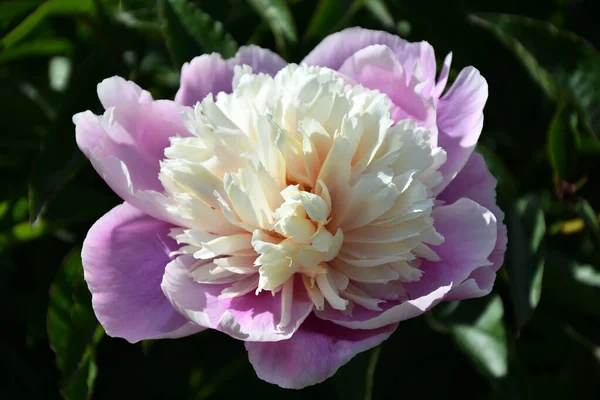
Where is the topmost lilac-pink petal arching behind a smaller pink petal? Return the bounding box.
[302,27,436,93]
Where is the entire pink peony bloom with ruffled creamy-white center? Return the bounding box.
[74,28,506,388]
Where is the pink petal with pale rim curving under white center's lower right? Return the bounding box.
[316,199,496,329]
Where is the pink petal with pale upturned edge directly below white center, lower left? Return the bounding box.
[162,256,313,342]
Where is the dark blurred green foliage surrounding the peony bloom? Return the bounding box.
[0,0,600,399]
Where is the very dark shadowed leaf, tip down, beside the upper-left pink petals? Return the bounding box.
[29,51,123,223]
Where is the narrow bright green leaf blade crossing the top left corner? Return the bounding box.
[0,0,95,48]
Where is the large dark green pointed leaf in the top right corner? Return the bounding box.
[470,14,600,144]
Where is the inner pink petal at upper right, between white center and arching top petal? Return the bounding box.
[339,45,436,128]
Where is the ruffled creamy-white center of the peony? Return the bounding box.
[160,65,445,326]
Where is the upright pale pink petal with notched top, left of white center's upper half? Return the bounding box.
[73,77,189,222]
